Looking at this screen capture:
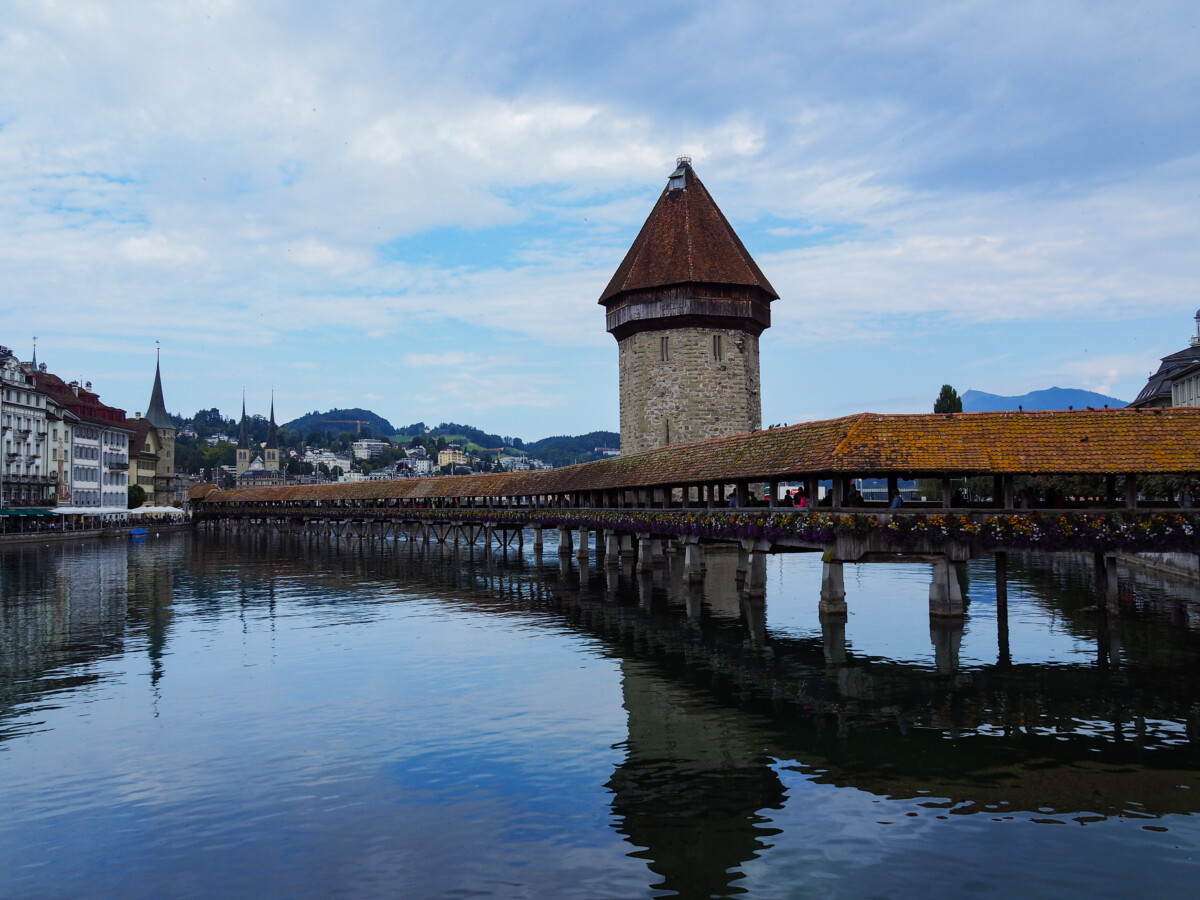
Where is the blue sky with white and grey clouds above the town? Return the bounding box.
[0,0,1200,440]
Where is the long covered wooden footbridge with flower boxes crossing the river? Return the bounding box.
[191,408,1200,618]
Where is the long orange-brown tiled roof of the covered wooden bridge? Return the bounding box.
[201,407,1200,503]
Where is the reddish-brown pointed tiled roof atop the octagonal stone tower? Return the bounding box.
[600,157,779,304]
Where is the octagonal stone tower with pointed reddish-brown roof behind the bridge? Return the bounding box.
[600,156,779,455]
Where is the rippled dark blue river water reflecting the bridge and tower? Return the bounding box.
[0,535,1200,898]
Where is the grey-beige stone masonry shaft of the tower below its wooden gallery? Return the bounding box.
[619,328,762,454]
